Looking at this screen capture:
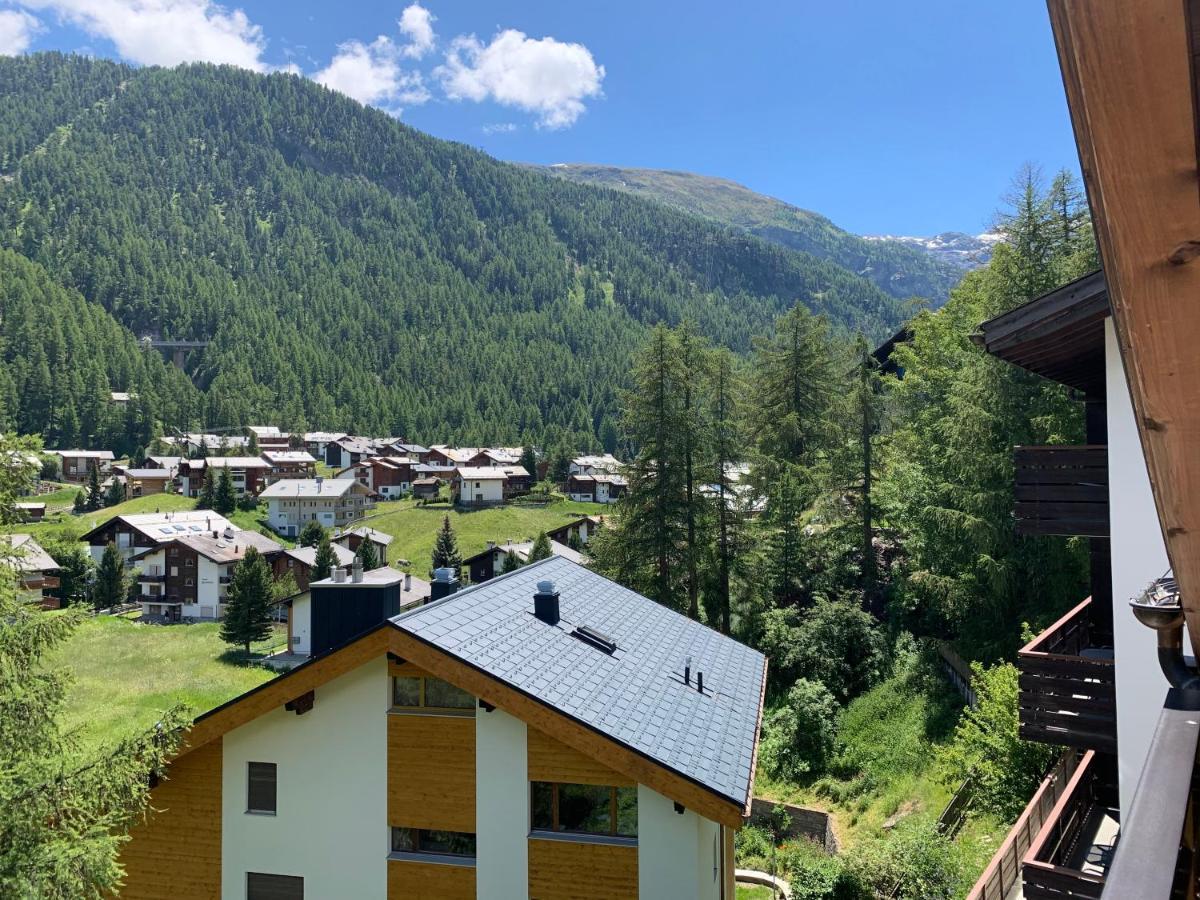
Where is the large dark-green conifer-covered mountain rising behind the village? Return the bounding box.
[0,54,902,445]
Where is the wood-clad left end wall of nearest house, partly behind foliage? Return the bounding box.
[120,738,221,900]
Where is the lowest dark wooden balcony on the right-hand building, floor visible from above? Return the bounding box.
[1021,751,1120,900]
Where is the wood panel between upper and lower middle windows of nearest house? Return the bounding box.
[388,714,475,833]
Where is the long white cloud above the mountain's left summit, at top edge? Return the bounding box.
[17,0,268,72]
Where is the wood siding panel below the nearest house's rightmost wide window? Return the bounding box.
[529,838,637,900]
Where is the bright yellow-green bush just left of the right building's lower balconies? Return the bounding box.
[941,662,1056,821]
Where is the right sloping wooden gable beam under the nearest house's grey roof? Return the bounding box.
[390,629,749,829]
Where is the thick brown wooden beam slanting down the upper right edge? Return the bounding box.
[1049,0,1200,647]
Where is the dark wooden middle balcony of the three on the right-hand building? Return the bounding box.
[1016,598,1117,754]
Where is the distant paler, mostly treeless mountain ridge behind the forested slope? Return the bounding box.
[535,163,964,306]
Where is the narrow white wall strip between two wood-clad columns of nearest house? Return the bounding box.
[475,709,529,900]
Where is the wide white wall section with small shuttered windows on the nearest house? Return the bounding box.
[221,656,389,900]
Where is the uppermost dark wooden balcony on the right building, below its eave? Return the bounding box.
[1013,444,1109,538]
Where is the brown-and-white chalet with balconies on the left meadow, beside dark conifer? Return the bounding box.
[130,528,283,622]
